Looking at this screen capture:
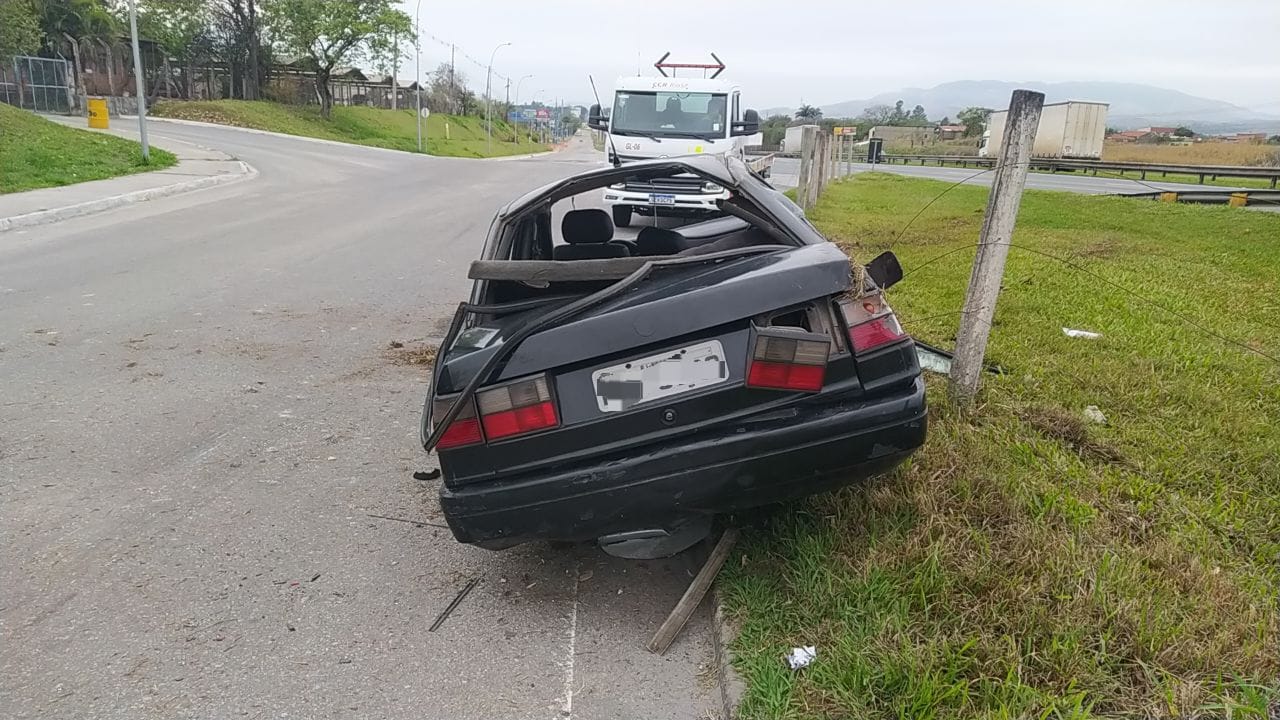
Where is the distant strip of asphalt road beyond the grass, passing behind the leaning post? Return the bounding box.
[773,158,1254,195]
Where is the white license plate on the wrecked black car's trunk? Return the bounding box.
[591,340,728,413]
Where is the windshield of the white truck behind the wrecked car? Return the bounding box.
[609,91,728,140]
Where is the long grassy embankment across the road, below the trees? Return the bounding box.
[152,100,548,158]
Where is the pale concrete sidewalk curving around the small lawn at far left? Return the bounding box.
[0,115,257,232]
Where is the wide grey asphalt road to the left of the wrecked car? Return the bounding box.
[0,123,717,720]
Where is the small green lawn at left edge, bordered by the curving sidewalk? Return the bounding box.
[0,102,178,193]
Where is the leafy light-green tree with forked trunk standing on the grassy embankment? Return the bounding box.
[264,0,413,118]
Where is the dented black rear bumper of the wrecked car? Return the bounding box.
[440,375,927,547]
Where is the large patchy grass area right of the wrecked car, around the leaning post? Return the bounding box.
[722,174,1280,719]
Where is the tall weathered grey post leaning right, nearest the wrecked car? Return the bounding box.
[951,90,1044,404]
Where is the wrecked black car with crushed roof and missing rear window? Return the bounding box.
[422,156,925,550]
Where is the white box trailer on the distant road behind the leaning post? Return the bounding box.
[978,100,1108,160]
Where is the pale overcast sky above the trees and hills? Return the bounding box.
[401,0,1280,114]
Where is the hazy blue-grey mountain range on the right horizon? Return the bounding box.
[765,81,1280,133]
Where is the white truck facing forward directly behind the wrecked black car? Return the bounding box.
[588,53,772,227]
